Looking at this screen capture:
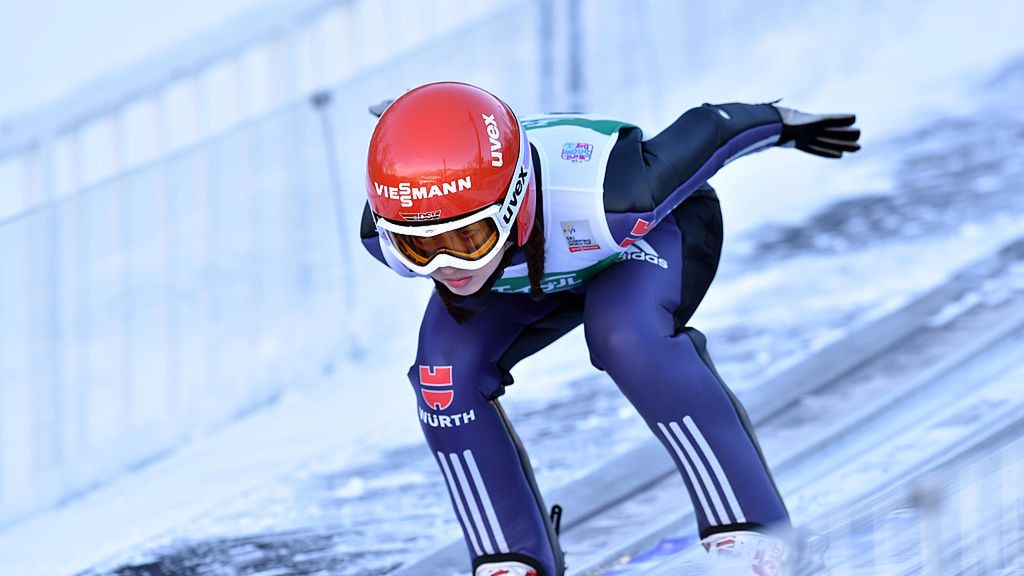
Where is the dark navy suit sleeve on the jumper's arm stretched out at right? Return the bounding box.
[604,104,782,247]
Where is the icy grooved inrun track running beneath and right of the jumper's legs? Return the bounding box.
[562,268,1024,576]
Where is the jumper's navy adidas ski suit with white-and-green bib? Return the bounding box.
[361,104,788,576]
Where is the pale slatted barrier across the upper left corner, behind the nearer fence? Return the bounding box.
[0,0,510,220]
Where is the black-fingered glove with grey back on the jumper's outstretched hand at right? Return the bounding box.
[775,106,860,158]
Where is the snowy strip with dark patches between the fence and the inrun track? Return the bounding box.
[0,2,1024,576]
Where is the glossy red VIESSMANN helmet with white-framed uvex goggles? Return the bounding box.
[367,82,537,274]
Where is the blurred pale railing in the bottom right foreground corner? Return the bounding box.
[812,440,1024,576]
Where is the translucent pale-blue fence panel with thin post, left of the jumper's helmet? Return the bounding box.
[0,1,536,526]
